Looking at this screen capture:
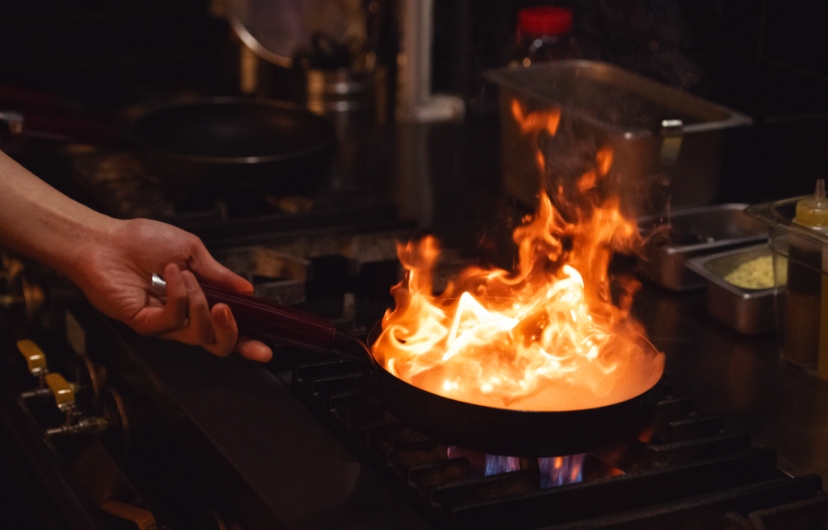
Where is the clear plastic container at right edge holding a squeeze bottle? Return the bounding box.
[746,197,828,374]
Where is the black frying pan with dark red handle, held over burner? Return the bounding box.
[160,276,662,457]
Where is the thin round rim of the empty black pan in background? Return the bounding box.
[129,96,336,165]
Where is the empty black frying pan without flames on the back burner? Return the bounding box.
[130,97,336,200]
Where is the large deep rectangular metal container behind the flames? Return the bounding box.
[487,61,751,214]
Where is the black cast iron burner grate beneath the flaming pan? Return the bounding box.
[291,361,828,530]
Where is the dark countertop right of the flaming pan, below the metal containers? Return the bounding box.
[634,285,828,480]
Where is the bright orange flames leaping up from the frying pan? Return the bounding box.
[372,102,663,411]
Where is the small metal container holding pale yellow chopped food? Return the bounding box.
[687,244,776,335]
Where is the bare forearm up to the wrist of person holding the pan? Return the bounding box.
[0,147,118,274]
